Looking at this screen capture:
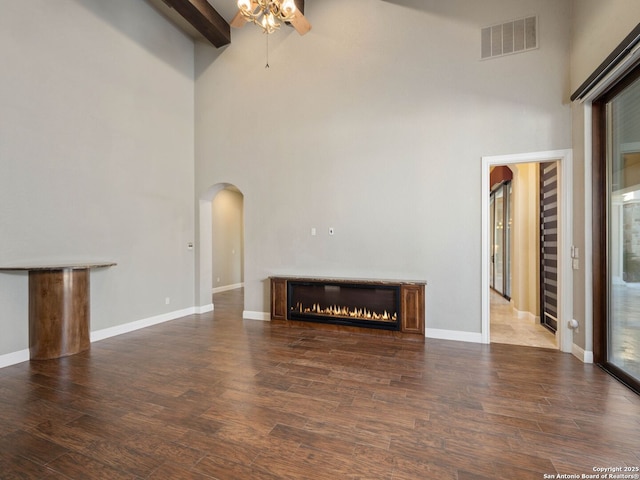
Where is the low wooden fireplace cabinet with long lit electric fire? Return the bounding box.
[270,276,426,339]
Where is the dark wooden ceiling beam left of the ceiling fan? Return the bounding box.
[163,0,230,48]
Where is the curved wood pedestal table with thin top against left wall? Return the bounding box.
[0,263,115,360]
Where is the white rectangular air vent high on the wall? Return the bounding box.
[481,16,538,58]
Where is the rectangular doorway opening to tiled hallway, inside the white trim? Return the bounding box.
[489,162,558,349]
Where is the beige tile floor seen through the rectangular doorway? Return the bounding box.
[490,291,558,349]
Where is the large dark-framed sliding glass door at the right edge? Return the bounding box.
[594,65,640,391]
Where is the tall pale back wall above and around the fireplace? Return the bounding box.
[196,0,571,333]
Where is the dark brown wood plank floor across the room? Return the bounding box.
[0,291,640,480]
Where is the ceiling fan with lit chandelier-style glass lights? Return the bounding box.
[230,0,311,35]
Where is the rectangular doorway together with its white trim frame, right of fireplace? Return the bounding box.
[482,150,573,352]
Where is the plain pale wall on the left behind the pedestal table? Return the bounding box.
[0,0,195,355]
